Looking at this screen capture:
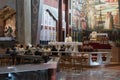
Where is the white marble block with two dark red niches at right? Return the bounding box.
[80,51,111,66]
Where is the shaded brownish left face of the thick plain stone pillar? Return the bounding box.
[16,0,25,43]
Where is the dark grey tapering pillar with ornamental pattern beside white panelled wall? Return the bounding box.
[31,0,41,44]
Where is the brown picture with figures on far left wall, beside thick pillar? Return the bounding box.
[0,0,16,41]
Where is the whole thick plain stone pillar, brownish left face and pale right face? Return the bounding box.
[16,0,31,44]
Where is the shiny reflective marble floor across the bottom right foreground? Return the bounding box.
[57,66,120,80]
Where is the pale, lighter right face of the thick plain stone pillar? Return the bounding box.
[24,0,31,44]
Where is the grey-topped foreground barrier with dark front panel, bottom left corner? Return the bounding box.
[0,56,59,80]
